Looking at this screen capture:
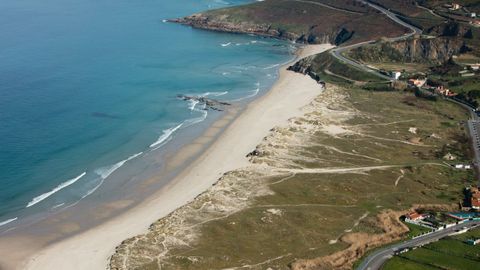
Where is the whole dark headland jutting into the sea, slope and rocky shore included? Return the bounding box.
[172,0,408,45]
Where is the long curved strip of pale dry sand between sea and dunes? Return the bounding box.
[11,44,332,270]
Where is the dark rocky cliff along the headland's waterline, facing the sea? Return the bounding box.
[170,13,344,44]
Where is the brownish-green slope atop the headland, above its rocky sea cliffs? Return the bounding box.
[200,0,405,42]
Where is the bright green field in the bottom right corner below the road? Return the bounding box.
[382,229,480,270]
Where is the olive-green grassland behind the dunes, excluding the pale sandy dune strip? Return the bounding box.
[120,85,473,269]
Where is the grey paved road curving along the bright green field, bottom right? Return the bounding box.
[357,221,480,270]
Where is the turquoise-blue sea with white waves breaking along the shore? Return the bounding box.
[0,0,292,230]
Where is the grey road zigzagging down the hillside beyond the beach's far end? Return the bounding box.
[330,1,422,80]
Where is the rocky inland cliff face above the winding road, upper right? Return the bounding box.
[349,37,468,64]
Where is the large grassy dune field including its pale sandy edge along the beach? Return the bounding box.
[111,83,473,269]
